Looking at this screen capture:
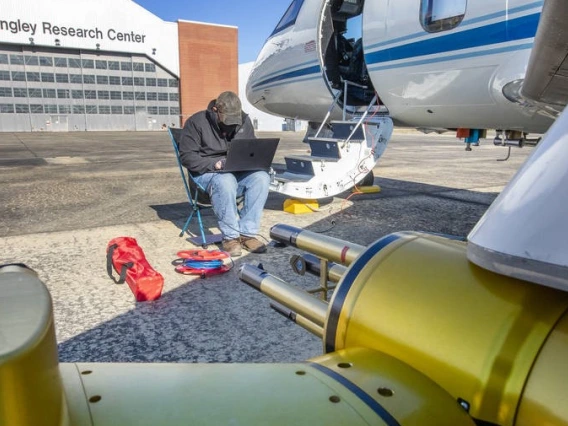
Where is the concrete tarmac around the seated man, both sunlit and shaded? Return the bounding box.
[0,132,532,362]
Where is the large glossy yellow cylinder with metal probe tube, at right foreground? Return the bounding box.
[247,225,568,426]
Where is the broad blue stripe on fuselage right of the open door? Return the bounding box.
[365,13,540,67]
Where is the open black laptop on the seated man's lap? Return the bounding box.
[221,138,280,172]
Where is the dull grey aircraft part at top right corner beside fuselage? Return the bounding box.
[521,0,568,111]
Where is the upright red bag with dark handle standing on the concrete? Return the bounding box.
[107,237,164,302]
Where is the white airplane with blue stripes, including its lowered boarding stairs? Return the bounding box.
[246,0,566,199]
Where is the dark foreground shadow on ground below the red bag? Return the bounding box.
[59,262,321,362]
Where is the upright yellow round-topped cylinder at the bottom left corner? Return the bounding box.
[0,265,67,426]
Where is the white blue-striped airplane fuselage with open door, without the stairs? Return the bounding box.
[247,0,553,133]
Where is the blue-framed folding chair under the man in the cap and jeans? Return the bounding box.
[168,127,223,248]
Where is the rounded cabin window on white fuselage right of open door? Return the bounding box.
[420,0,467,33]
